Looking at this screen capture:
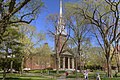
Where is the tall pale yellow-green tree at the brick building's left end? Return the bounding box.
[19,24,45,73]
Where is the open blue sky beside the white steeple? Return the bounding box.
[32,0,70,47]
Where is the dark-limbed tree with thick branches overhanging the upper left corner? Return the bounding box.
[0,0,43,43]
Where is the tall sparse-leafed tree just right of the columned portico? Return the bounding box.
[65,3,89,77]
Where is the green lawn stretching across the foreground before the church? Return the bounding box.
[0,70,120,80]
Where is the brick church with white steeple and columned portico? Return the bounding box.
[25,0,75,70]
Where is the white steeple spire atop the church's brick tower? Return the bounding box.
[57,0,66,35]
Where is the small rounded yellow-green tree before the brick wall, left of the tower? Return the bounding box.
[35,43,52,69]
